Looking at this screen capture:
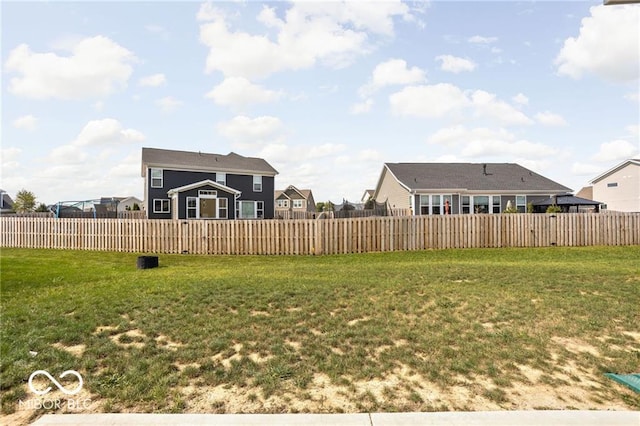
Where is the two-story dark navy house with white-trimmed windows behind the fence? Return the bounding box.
[142,148,278,219]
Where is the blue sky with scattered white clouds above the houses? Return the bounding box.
[0,1,640,203]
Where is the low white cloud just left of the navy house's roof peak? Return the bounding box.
[72,118,145,146]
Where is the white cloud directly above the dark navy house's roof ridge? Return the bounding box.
[217,115,284,149]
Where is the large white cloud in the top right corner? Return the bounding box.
[555,5,640,81]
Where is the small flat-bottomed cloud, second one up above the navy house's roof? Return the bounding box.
[205,77,282,109]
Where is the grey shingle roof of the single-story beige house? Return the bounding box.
[385,163,571,193]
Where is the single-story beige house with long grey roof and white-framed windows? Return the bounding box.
[373,163,571,215]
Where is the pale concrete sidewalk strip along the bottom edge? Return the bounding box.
[32,410,640,426]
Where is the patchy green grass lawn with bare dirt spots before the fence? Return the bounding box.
[0,246,640,415]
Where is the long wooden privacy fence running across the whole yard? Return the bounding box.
[0,213,640,255]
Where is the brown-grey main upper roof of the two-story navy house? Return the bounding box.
[142,148,278,177]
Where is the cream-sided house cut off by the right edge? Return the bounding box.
[581,158,640,212]
